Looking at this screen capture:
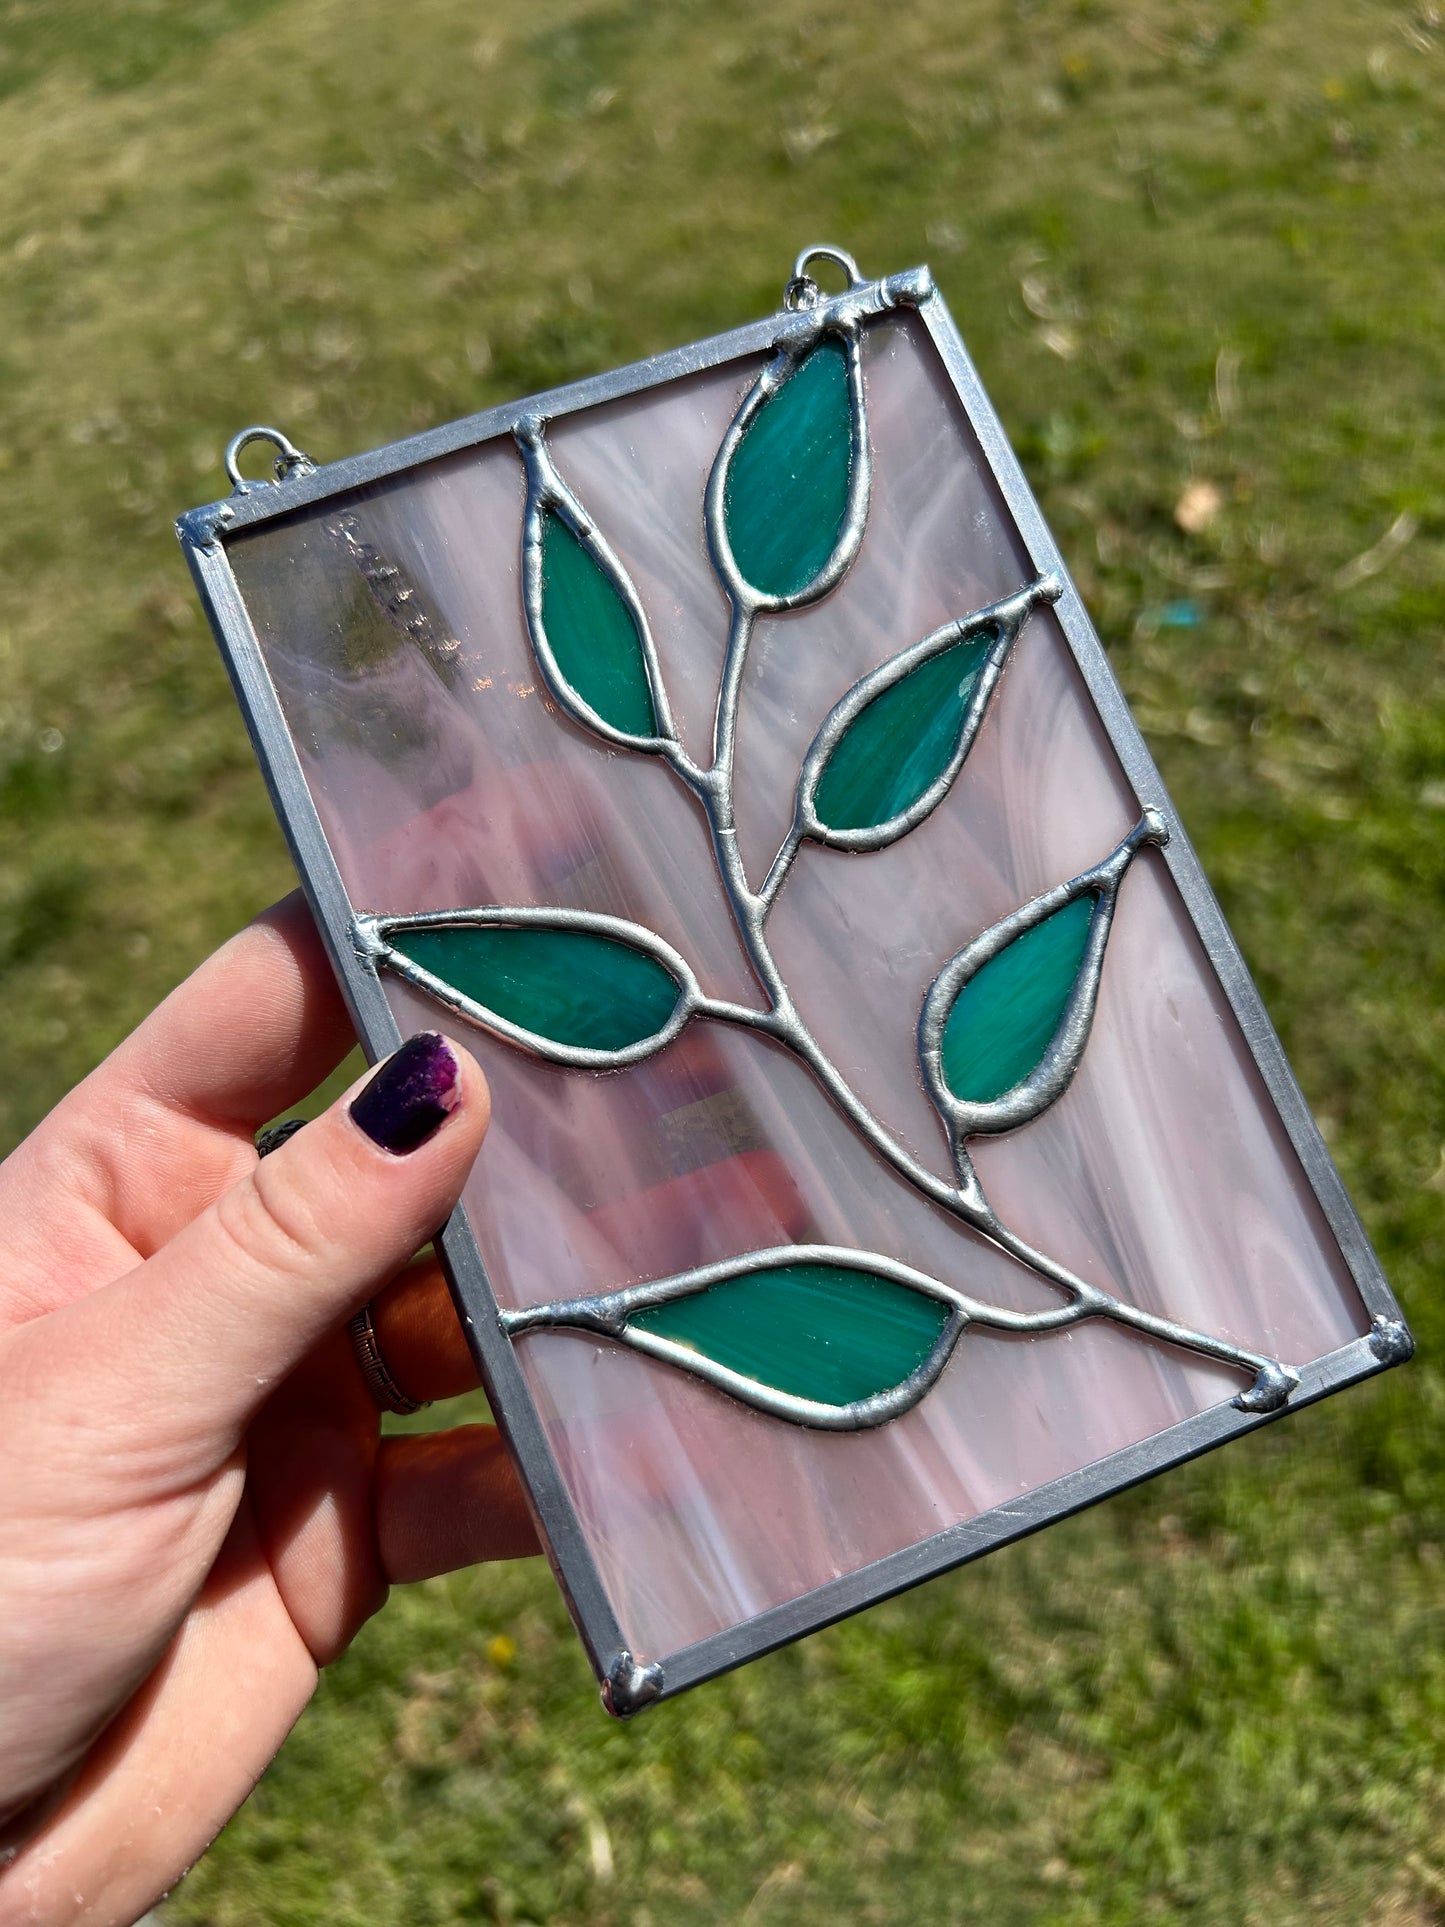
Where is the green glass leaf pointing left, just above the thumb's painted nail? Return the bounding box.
[387,923,682,1050]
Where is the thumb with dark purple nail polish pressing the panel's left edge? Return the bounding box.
[37,1031,489,1474]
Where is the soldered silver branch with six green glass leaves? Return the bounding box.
[356,267,1299,1430]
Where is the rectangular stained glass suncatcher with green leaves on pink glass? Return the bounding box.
[181,248,1410,1713]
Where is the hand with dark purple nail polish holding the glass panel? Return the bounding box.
[0,898,536,1927]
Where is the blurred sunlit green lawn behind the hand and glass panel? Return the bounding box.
[0,0,1445,1927]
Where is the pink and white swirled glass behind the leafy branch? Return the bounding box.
[231,318,1368,1659]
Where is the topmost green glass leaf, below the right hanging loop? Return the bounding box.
[723,335,854,595]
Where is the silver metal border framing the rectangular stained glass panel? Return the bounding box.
[177,268,1414,1715]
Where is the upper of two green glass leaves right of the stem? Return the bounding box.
[813,634,994,831]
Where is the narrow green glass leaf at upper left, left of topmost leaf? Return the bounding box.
[541,509,657,736]
